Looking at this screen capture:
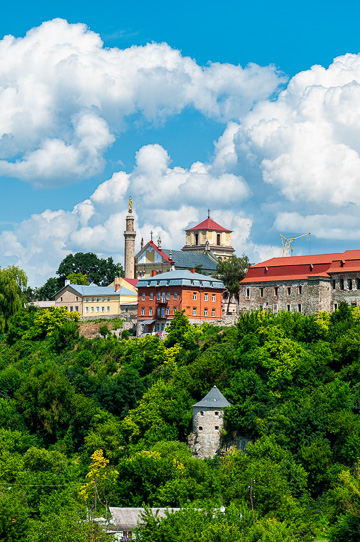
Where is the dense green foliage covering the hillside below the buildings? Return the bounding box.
[0,304,360,542]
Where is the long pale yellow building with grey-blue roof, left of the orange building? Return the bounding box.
[55,281,137,319]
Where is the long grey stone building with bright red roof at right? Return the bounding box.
[239,250,360,315]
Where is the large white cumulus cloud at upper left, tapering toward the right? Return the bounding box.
[0,19,283,187]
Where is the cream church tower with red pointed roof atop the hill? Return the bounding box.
[181,215,235,260]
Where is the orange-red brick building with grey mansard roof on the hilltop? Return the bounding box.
[137,269,225,335]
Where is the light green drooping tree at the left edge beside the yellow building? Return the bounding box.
[0,266,27,331]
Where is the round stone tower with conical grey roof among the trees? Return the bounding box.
[189,386,231,459]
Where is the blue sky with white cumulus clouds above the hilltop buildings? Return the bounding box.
[0,0,360,286]
